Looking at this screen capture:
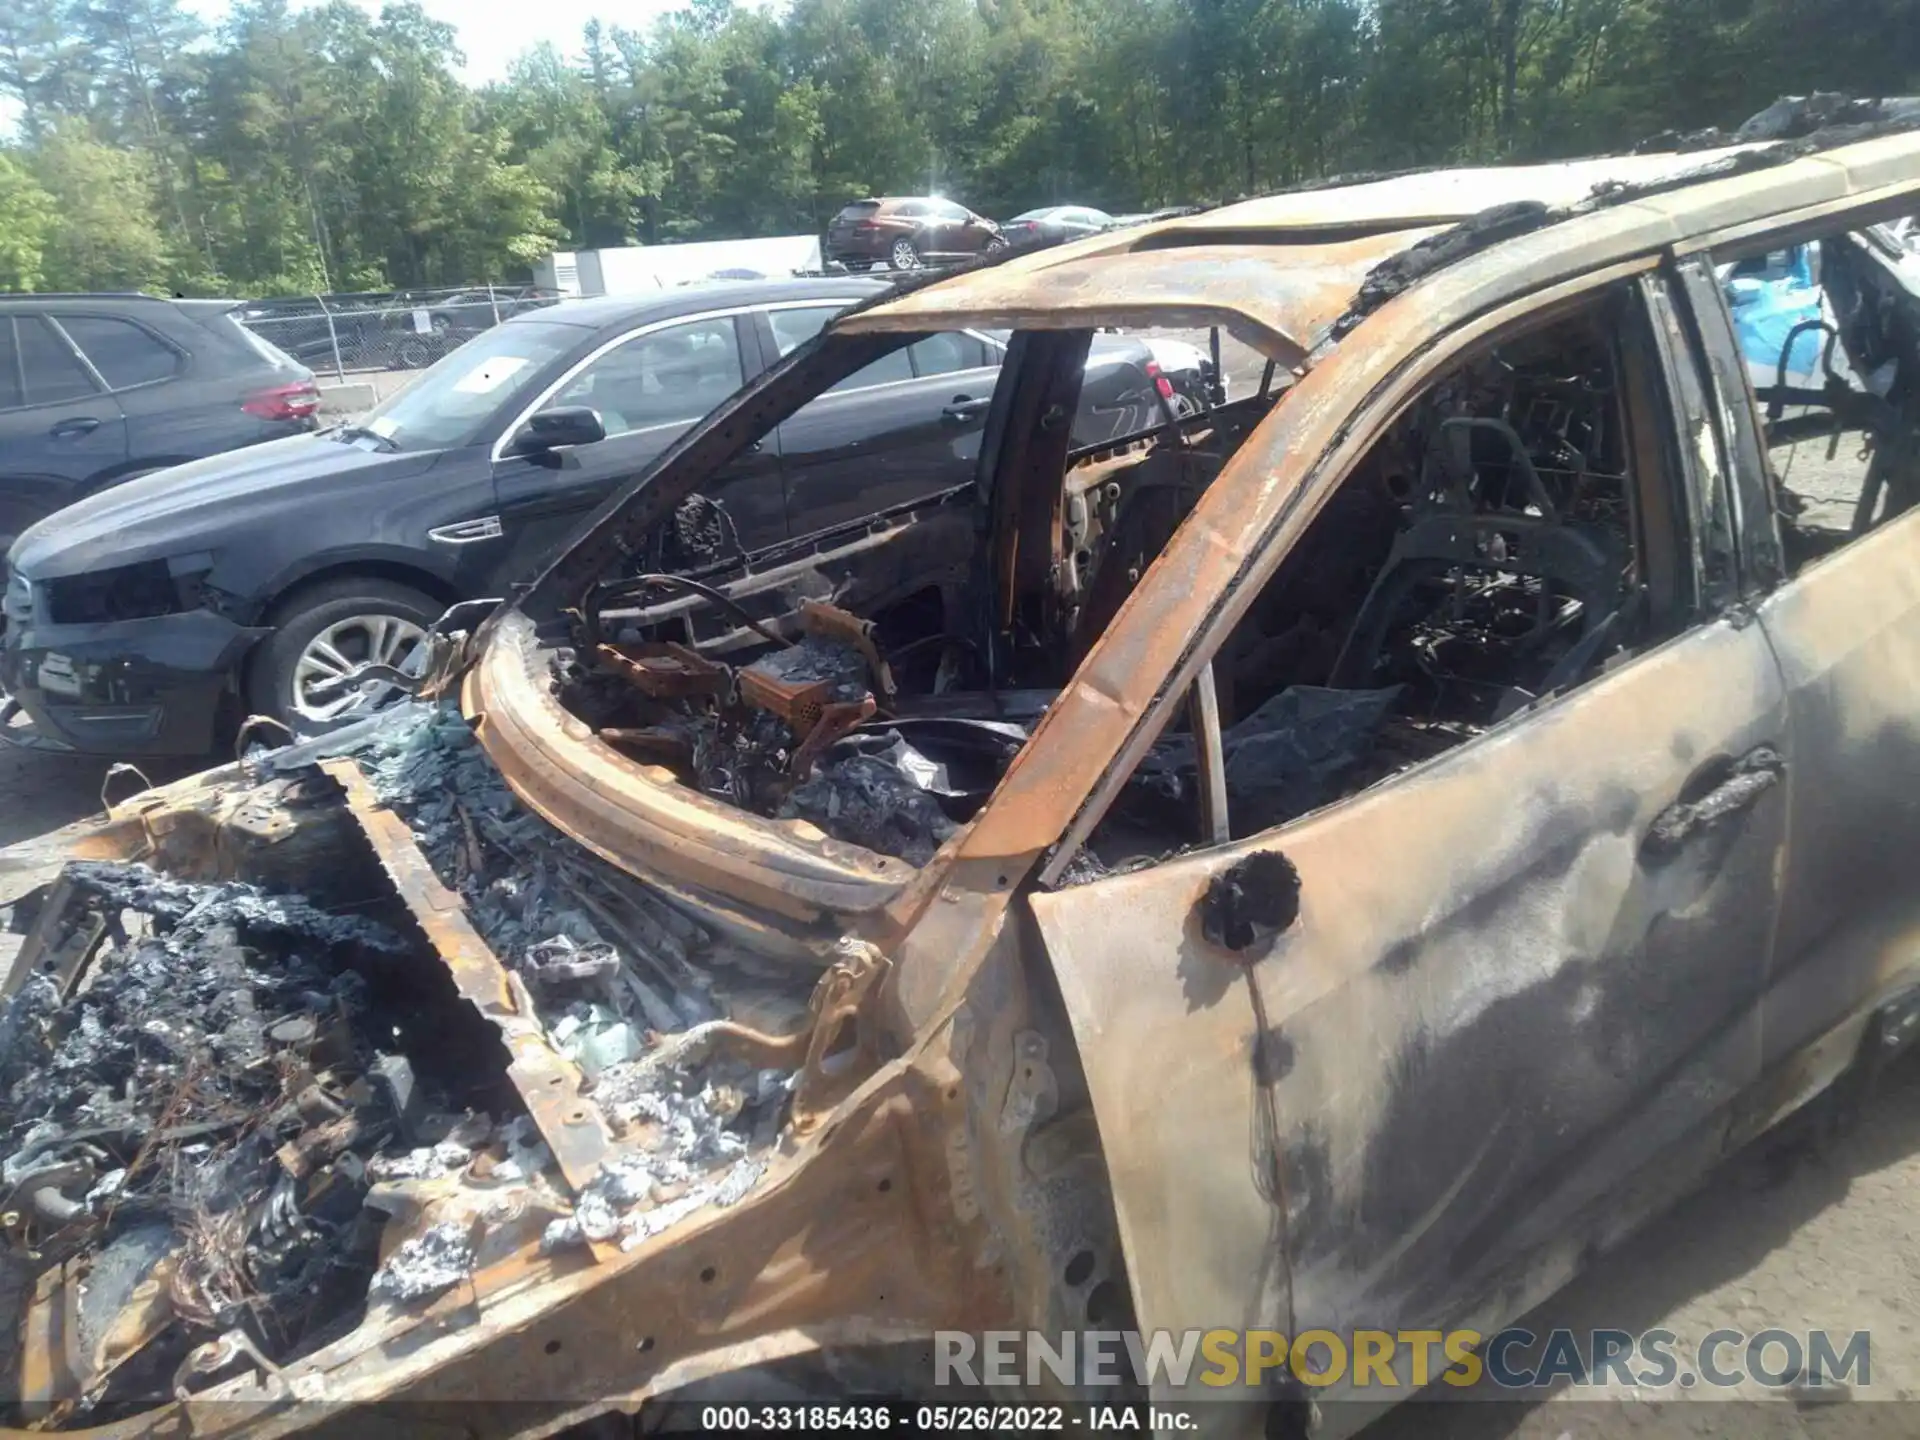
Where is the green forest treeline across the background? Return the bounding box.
[0,0,1920,294]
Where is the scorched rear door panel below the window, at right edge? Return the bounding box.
[1761,511,1920,1064]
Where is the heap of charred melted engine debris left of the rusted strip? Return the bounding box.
[0,862,449,1382]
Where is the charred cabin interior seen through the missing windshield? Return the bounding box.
[549,330,1284,866]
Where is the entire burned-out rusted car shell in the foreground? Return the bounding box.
[11,109,1920,1434]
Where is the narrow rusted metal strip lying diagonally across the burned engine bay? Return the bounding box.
[321,760,612,1190]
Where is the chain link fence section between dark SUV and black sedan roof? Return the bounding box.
[238,284,561,380]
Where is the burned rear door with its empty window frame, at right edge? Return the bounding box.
[1682,184,1920,1133]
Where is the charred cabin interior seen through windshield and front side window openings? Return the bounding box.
[545,307,1649,879]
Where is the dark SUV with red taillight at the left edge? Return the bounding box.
[0,296,321,553]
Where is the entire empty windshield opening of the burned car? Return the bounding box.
[541,320,1279,866]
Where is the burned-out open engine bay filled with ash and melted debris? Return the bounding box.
[0,705,818,1428]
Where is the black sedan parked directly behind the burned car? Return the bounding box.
[0,276,1210,755]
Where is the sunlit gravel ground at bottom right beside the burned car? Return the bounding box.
[1367,1060,1920,1440]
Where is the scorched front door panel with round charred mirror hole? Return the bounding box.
[1033,622,1791,1397]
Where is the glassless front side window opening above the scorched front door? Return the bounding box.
[1060,290,1693,883]
